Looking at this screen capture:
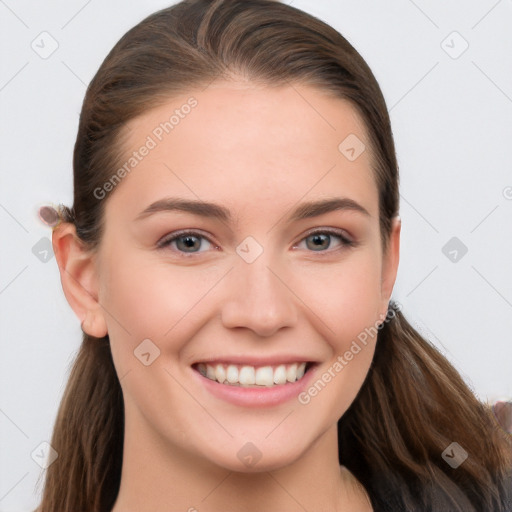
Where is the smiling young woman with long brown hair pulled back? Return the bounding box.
[35,0,512,512]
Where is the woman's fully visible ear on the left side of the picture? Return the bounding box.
[52,222,108,338]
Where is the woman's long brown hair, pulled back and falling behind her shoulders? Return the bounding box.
[39,0,512,512]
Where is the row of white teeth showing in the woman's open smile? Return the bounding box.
[192,362,314,387]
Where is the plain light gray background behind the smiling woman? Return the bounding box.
[0,0,512,512]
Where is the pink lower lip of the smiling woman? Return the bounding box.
[192,365,316,407]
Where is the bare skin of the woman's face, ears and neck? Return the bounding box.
[53,82,400,512]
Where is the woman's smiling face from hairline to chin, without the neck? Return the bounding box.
[95,82,399,471]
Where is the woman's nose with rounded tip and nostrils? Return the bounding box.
[221,252,298,337]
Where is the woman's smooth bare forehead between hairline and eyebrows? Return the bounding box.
[104,82,378,221]
